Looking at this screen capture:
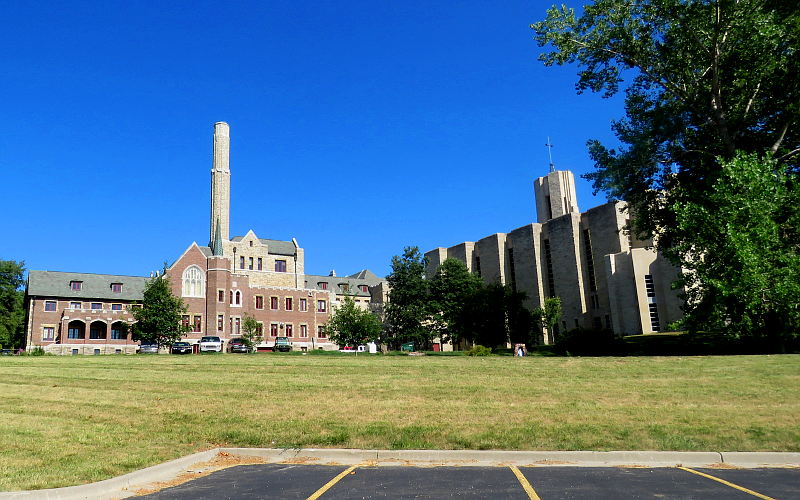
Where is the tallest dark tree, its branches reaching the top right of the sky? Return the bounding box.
[531,0,800,340]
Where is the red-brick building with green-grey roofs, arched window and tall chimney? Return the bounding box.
[26,122,383,354]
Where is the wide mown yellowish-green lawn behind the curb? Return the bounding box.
[0,354,800,490]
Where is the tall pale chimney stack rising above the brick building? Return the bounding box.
[208,122,231,247]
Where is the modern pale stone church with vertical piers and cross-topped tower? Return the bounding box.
[425,171,681,343]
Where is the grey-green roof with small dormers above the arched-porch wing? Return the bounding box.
[27,270,149,300]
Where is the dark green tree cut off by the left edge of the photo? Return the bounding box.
[0,260,25,349]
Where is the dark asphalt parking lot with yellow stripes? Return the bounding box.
[138,464,800,500]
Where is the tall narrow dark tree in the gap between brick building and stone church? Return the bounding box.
[385,247,434,349]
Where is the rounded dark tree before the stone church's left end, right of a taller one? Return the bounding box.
[429,259,483,345]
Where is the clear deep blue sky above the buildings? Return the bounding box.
[0,0,623,275]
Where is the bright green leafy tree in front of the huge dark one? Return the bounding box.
[674,154,800,345]
